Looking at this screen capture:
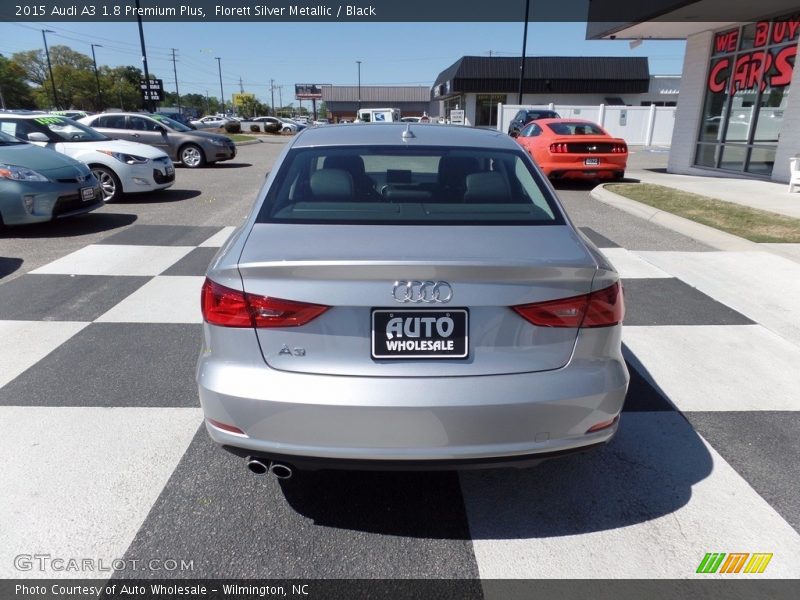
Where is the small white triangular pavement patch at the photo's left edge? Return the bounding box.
[0,321,89,387]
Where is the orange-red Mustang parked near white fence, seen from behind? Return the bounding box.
[516,119,628,179]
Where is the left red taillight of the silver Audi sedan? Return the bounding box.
[200,279,330,328]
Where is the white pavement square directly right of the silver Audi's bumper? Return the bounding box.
[622,325,800,412]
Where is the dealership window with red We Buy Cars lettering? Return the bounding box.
[695,13,800,177]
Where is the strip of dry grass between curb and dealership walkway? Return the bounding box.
[605,183,800,243]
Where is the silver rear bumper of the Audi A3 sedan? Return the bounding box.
[197,325,628,468]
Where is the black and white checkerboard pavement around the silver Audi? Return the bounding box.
[0,225,800,578]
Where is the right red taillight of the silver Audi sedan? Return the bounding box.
[511,282,625,327]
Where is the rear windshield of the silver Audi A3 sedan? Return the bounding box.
[258,146,564,225]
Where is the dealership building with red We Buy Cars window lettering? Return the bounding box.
[587,0,800,182]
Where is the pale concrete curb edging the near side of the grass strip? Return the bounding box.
[589,184,769,252]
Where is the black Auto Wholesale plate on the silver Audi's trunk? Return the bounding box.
[372,308,469,358]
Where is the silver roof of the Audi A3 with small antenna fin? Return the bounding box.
[292,123,519,150]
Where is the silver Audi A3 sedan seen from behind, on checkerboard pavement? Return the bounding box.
[197,123,628,477]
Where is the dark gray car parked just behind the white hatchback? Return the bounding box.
[80,112,236,169]
